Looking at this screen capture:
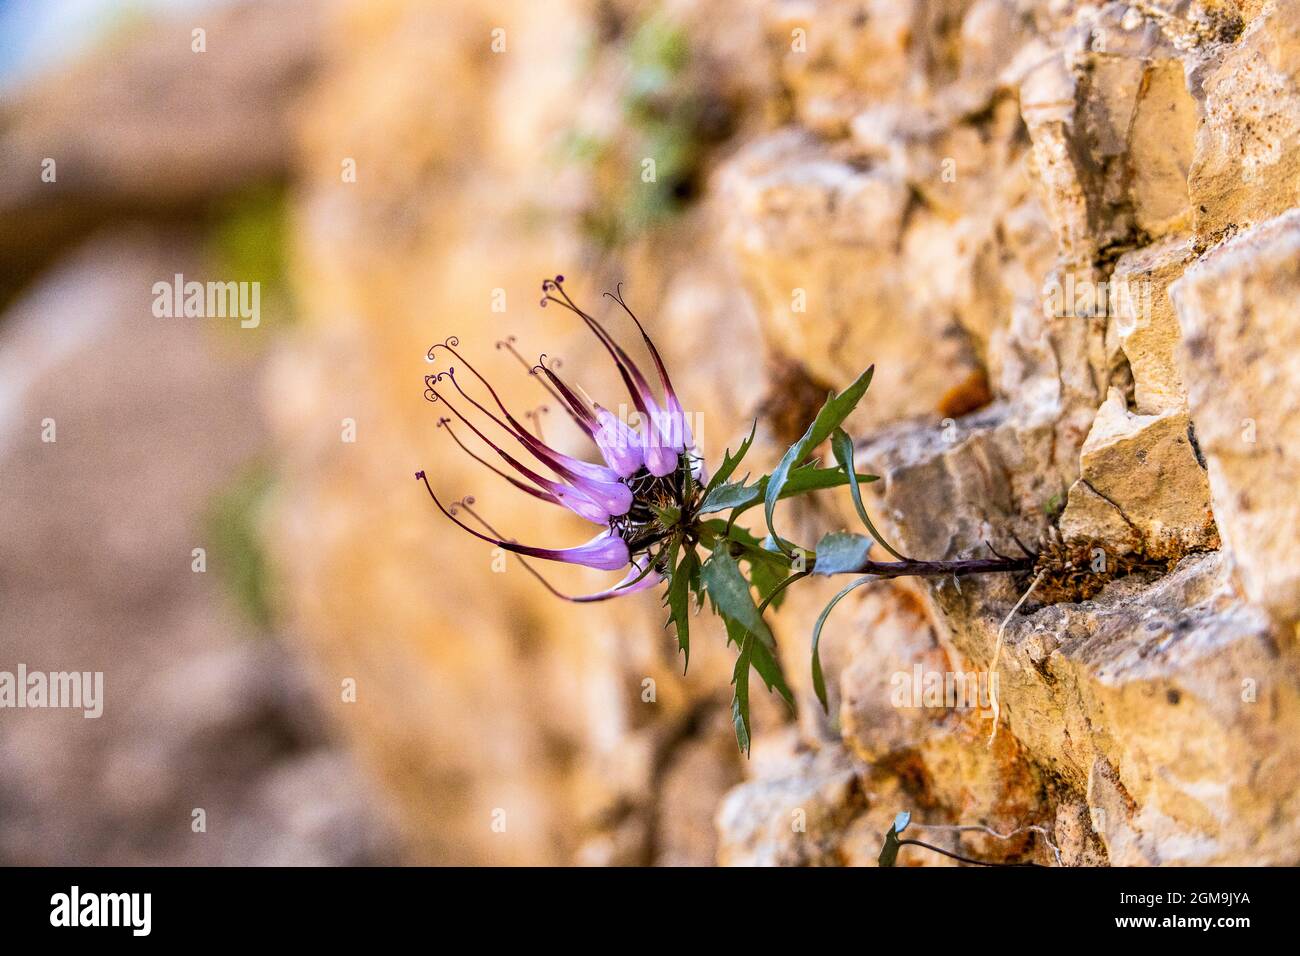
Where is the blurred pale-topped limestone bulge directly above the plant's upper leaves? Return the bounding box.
[720,128,975,421]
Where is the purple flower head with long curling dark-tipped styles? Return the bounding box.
[416,276,701,601]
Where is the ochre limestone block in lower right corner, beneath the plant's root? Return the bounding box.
[949,554,1300,865]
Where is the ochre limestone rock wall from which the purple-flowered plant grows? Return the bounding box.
[273,0,1300,865]
